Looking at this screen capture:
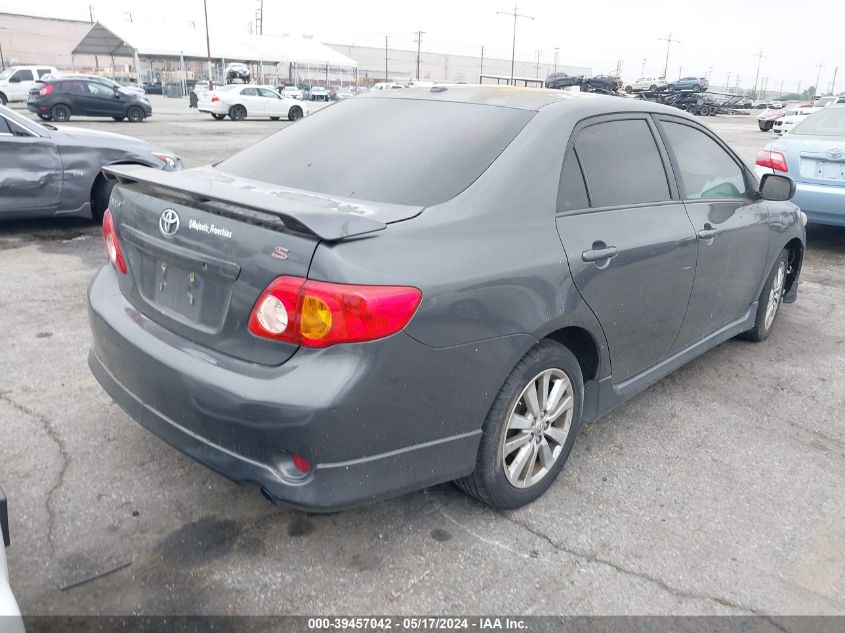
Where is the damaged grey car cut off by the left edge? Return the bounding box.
[0,106,182,220]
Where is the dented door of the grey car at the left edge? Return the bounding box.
[0,114,62,212]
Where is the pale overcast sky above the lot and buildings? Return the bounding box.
[0,0,845,92]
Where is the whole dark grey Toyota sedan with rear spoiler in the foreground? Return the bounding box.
[88,86,804,511]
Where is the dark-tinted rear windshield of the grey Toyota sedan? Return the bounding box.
[217,97,534,206]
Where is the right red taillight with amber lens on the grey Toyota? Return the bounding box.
[249,277,422,347]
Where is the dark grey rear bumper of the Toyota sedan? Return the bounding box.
[88,268,525,511]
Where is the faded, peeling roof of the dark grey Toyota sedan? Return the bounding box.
[367,84,682,115]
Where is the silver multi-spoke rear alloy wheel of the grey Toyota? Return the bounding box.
[502,368,575,488]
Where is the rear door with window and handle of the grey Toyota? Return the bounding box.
[557,114,696,384]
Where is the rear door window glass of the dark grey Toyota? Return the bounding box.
[575,119,670,207]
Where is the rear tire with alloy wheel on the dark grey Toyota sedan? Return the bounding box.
[455,340,584,509]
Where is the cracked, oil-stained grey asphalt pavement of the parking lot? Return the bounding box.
[0,97,845,614]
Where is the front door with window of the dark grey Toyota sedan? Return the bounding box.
[658,116,769,350]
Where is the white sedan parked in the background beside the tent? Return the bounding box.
[197,84,308,121]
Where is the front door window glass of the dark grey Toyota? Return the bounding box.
[663,121,746,200]
